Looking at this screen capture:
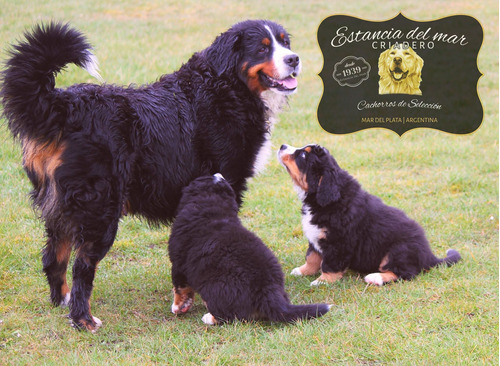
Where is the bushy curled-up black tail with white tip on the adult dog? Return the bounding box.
[0,22,100,138]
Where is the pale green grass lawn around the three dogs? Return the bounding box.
[0,0,499,365]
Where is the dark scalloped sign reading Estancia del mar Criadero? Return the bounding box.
[318,14,483,135]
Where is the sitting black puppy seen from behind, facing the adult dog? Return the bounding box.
[168,174,330,325]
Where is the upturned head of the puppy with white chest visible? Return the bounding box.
[278,145,341,206]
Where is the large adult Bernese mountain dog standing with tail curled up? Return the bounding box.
[0,20,301,331]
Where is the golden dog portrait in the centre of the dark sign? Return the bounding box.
[378,45,424,95]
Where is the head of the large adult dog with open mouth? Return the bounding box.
[205,20,302,95]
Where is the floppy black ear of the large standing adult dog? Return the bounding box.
[204,29,242,76]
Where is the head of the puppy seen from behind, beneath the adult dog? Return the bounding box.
[179,173,238,211]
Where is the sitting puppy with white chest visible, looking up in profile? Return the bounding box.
[278,145,460,286]
